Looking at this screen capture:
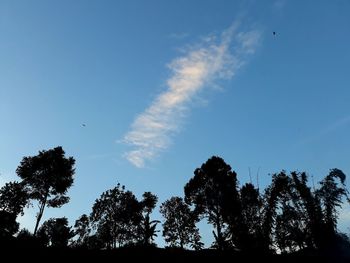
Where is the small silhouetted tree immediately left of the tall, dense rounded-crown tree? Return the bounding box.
[160,197,203,249]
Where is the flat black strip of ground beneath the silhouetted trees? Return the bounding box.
[0,243,350,263]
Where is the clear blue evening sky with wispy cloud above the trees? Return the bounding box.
[0,0,350,246]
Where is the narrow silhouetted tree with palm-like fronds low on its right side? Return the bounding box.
[140,192,160,246]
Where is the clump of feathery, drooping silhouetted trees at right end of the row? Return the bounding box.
[263,169,348,252]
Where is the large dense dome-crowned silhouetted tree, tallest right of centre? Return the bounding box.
[185,156,241,252]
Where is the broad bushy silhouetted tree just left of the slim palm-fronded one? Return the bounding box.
[90,183,142,248]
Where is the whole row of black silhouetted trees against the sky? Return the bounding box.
[0,147,350,253]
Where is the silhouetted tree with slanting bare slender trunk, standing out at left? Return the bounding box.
[16,147,75,235]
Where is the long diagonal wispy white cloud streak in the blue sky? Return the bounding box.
[123,23,260,168]
